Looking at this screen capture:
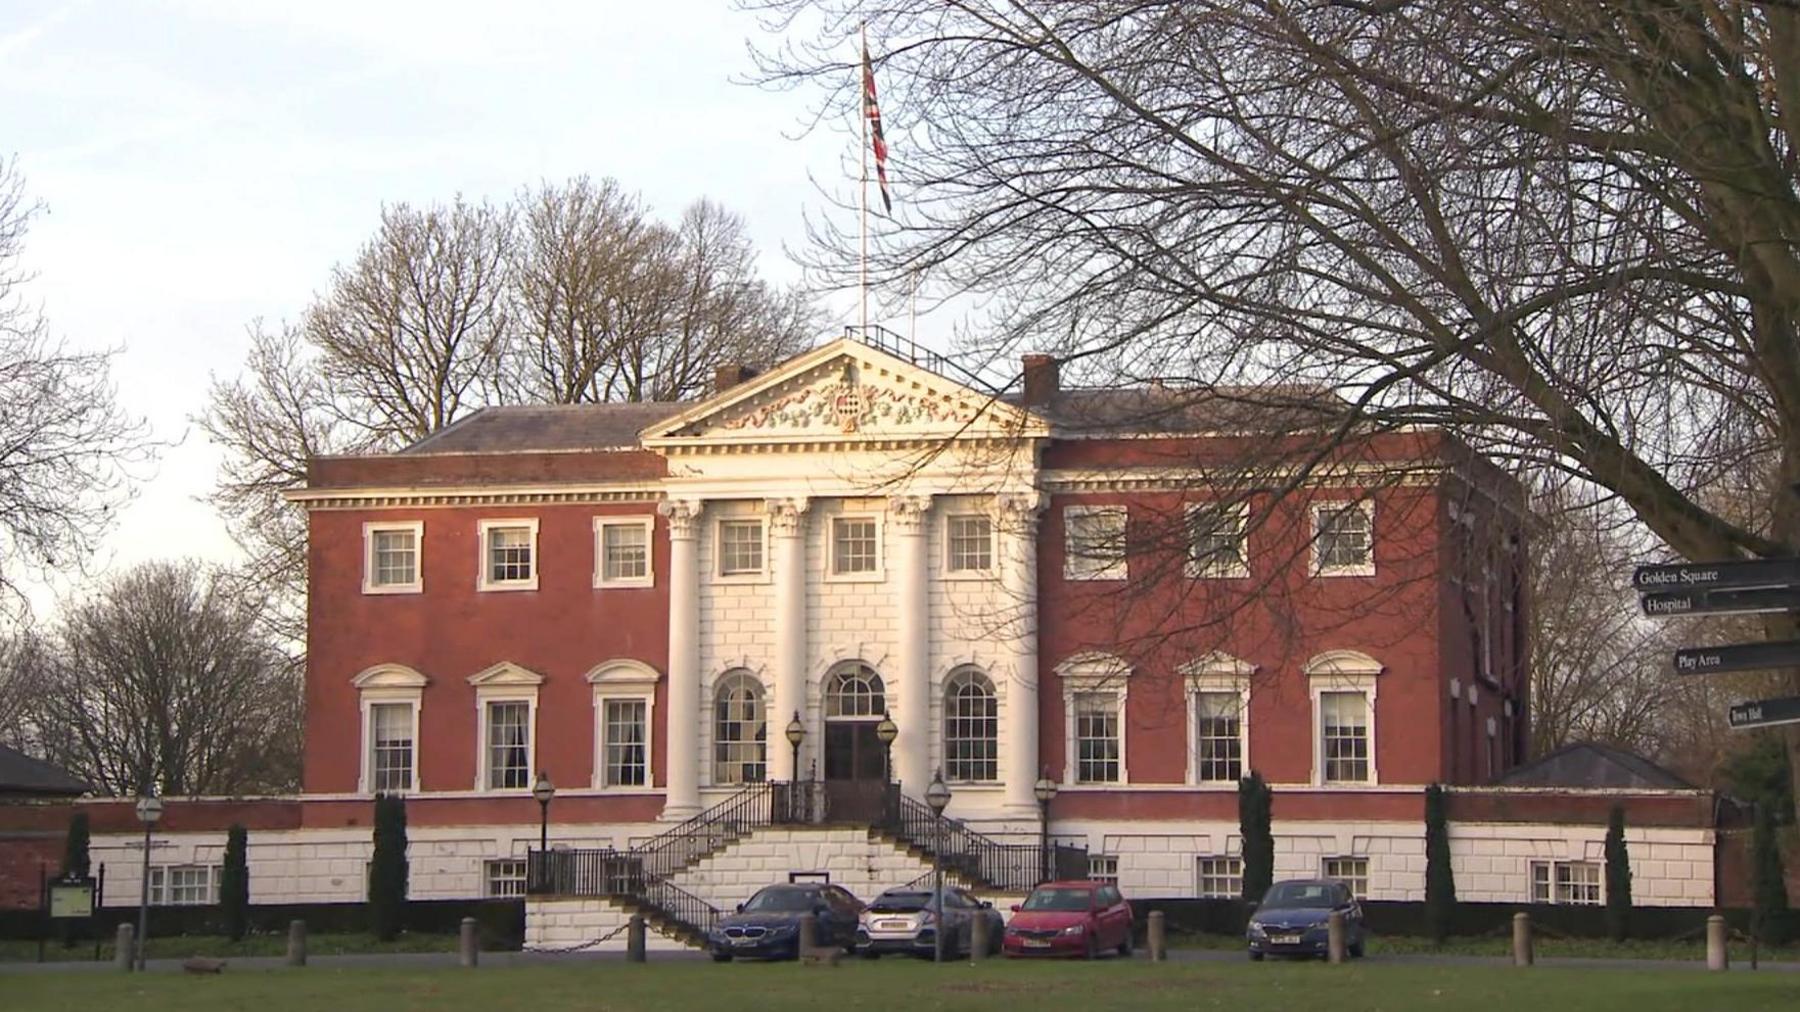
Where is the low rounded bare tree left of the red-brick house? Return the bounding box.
[29,562,301,794]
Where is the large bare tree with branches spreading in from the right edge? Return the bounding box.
[747,0,1800,813]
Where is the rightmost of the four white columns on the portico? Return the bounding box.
[999,492,1044,821]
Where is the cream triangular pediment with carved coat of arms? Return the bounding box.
[643,339,1049,447]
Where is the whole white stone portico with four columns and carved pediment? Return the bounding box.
[643,339,1049,821]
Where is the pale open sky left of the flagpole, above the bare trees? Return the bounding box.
[0,0,896,603]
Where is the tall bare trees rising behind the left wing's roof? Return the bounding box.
[198,176,817,626]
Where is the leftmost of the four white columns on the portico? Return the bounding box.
[657,499,702,821]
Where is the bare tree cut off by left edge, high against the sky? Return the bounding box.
[0,160,157,596]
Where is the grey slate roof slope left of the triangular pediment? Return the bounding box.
[401,402,691,454]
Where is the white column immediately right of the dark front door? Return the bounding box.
[887,495,934,798]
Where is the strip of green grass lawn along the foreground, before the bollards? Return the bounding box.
[0,960,1800,1012]
